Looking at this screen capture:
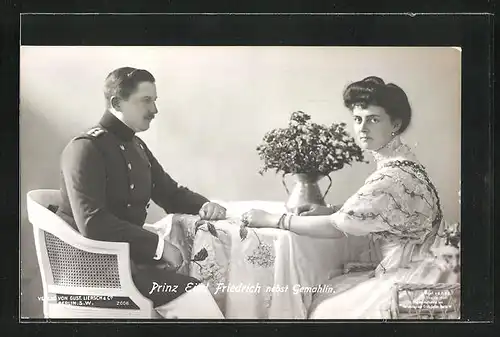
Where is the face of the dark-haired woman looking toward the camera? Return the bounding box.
[352,105,400,151]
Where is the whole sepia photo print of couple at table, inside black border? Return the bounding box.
[19,45,460,322]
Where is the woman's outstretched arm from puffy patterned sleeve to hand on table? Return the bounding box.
[242,163,435,238]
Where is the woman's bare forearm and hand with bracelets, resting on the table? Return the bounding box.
[243,209,345,239]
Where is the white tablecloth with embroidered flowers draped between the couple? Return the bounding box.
[158,201,370,319]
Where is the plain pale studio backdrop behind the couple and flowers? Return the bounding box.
[20,46,461,318]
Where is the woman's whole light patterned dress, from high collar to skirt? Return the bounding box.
[309,136,442,319]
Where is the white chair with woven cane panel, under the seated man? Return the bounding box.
[27,190,158,318]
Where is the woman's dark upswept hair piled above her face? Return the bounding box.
[343,76,411,133]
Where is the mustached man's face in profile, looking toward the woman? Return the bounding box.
[116,82,158,132]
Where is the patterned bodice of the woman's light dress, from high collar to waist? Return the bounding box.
[331,136,442,271]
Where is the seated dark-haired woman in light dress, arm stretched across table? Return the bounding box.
[242,76,448,319]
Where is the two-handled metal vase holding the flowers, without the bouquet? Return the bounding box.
[282,173,332,214]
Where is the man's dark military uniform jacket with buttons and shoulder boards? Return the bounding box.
[58,112,208,263]
